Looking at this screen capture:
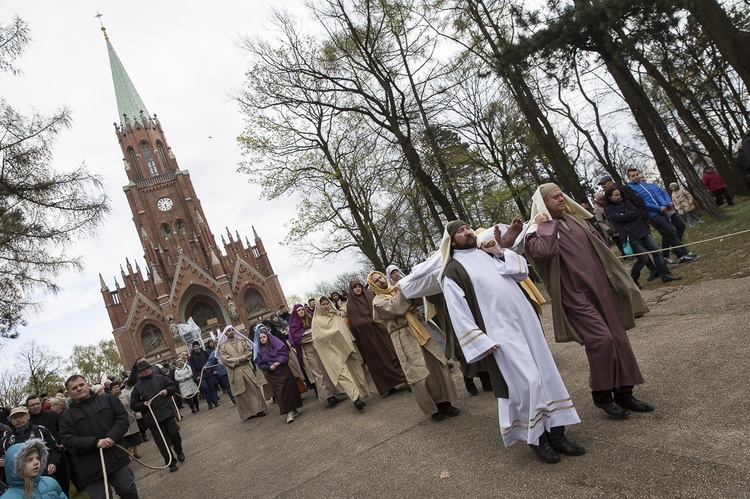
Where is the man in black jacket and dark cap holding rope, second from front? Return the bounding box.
[130,361,185,472]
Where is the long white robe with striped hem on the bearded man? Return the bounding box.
[443,249,581,447]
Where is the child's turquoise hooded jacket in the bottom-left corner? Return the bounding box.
[0,438,66,499]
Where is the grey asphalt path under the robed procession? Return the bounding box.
[133,278,750,499]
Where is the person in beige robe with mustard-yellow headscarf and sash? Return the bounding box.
[367,271,460,421]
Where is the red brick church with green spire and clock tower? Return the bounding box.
[99,28,286,367]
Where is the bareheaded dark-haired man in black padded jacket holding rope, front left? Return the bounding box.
[60,374,138,499]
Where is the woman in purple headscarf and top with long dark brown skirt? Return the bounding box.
[255,325,302,423]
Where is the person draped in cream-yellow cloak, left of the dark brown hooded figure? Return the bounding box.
[312,296,370,411]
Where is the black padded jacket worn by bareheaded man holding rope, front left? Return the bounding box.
[60,391,130,486]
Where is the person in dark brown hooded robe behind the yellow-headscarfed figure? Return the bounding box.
[346,279,406,396]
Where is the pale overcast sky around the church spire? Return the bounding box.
[0,0,356,367]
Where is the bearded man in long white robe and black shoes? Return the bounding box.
[440,220,585,463]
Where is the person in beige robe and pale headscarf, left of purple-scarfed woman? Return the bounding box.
[216,326,268,421]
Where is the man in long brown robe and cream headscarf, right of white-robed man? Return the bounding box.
[525,184,654,418]
